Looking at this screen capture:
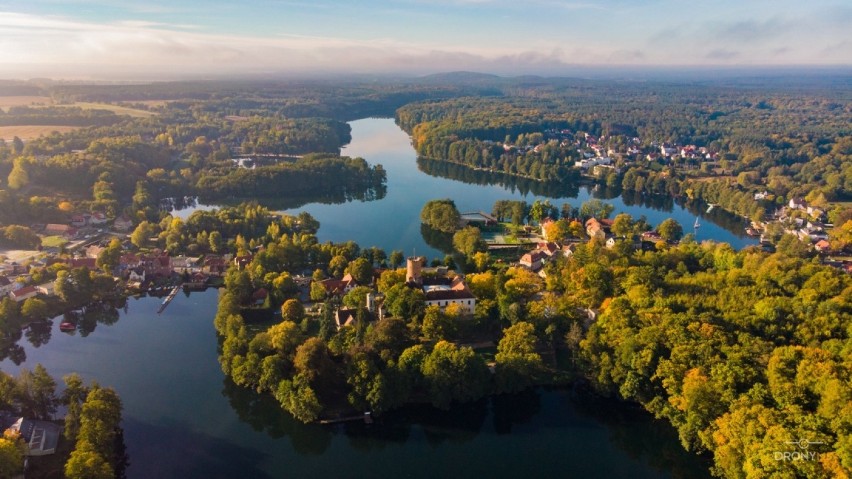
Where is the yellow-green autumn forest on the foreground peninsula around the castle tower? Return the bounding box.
[208,200,852,478]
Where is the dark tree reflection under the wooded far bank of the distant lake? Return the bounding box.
[417,157,579,198]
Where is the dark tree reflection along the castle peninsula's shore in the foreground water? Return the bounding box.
[222,378,709,479]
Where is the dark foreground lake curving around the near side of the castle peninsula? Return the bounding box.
[5,290,709,478]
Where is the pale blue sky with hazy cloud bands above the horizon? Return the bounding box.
[0,0,852,80]
